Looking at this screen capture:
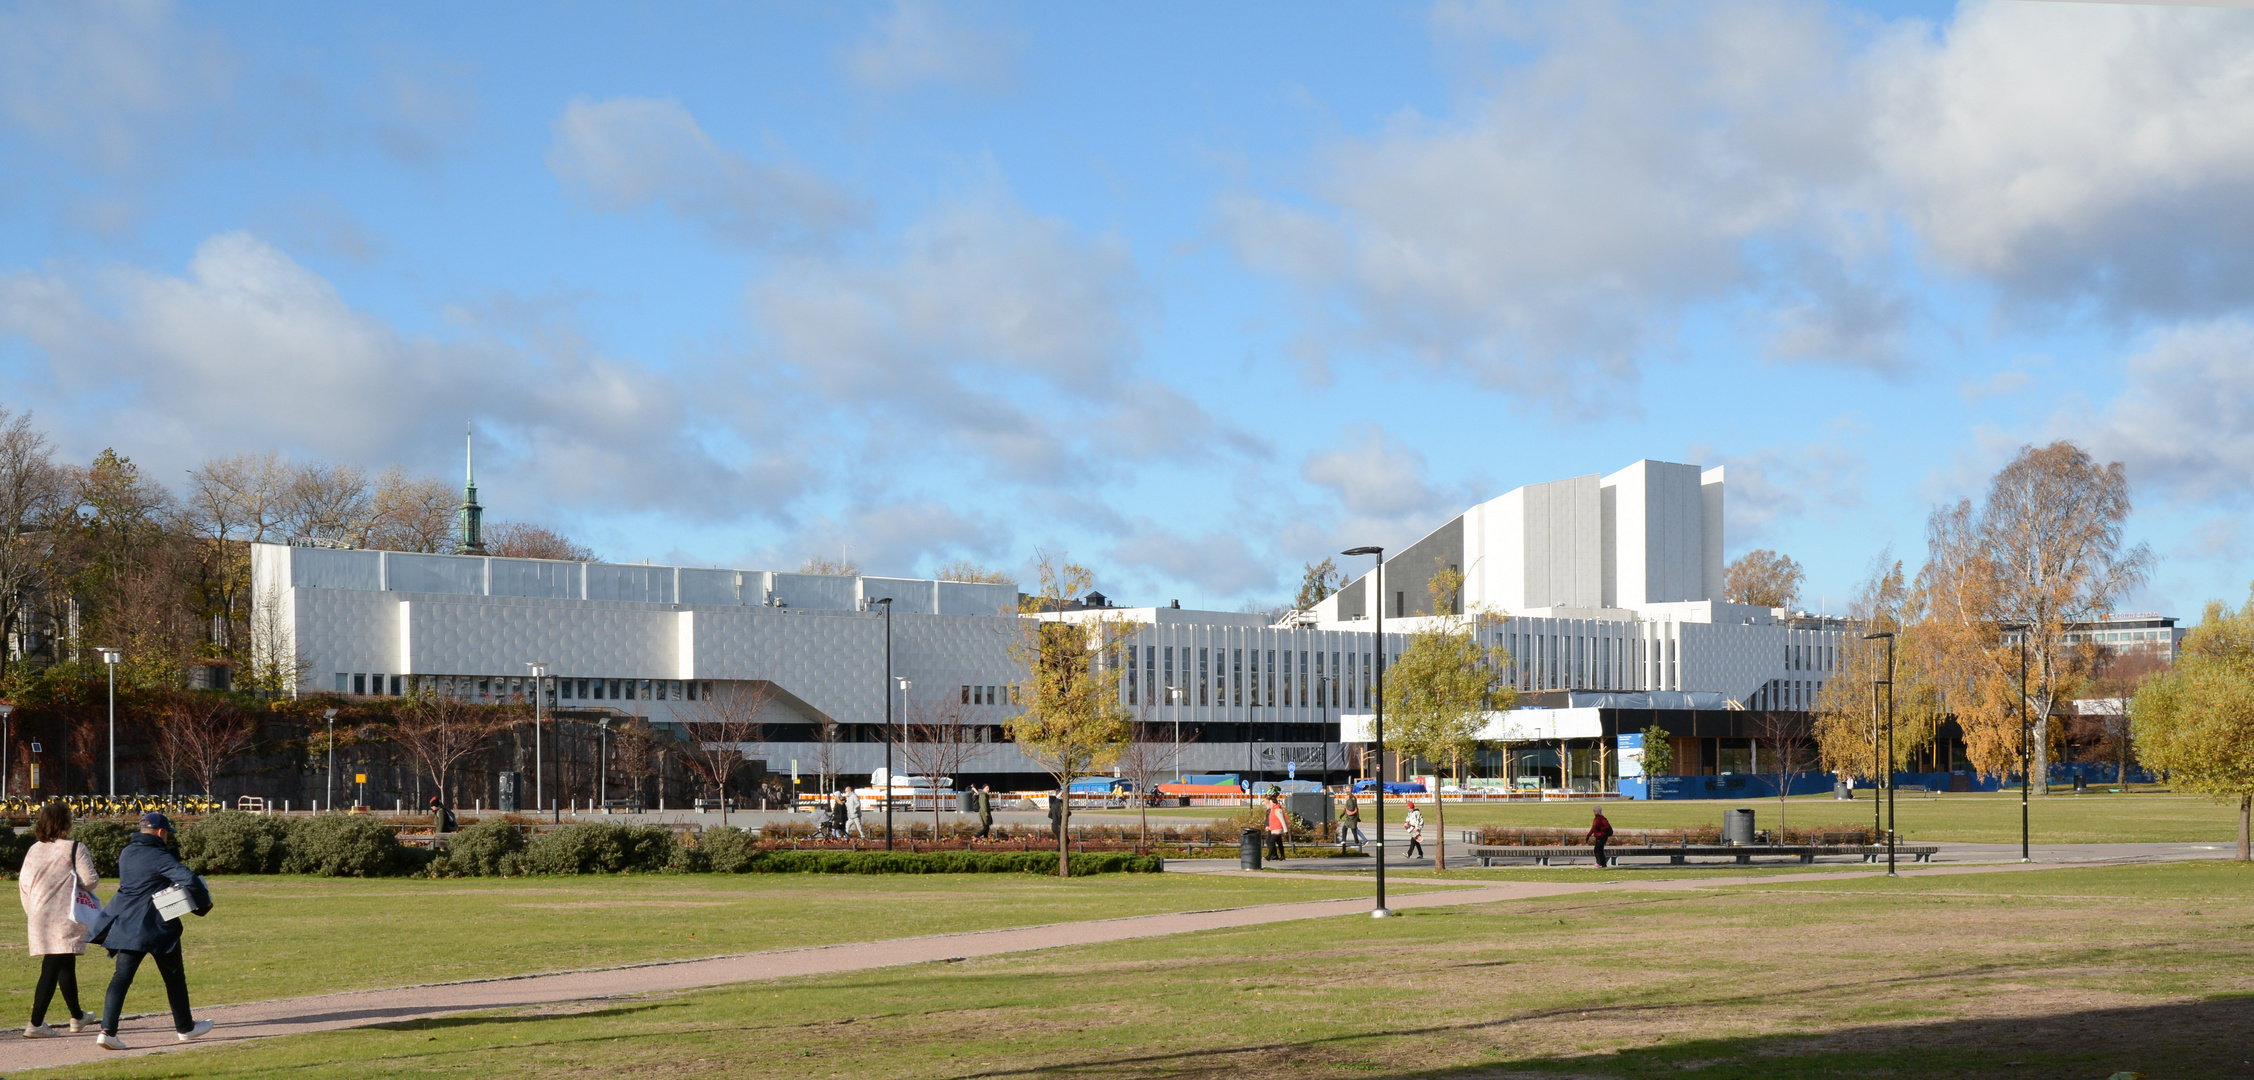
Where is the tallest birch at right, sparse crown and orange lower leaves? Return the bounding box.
[1920,442,2153,794]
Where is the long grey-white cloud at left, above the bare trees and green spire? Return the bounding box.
[0,232,802,516]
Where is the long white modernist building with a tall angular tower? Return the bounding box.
[252,460,1842,782]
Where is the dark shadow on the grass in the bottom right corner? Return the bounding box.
[933,997,2254,1080]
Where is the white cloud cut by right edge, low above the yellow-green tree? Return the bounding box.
[2051,318,2254,503]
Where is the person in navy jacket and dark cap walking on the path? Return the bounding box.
[86,812,212,1051]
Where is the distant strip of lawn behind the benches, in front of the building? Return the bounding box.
[1075,789,2238,843]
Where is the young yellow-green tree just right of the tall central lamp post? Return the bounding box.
[1386,566,1517,870]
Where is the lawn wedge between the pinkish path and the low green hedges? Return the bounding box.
[0,875,1442,1015]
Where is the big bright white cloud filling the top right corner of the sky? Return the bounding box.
[1864,2,2254,313]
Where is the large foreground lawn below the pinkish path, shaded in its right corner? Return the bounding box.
[39,864,2254,1080]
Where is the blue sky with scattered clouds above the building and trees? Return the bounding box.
[0,2,2254,616]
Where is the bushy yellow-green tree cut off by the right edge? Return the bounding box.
[2130,595,2254,861]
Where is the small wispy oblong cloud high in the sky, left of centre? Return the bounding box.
[548,97,863,246]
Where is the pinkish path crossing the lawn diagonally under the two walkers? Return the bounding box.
[0,859,2199,1071]
